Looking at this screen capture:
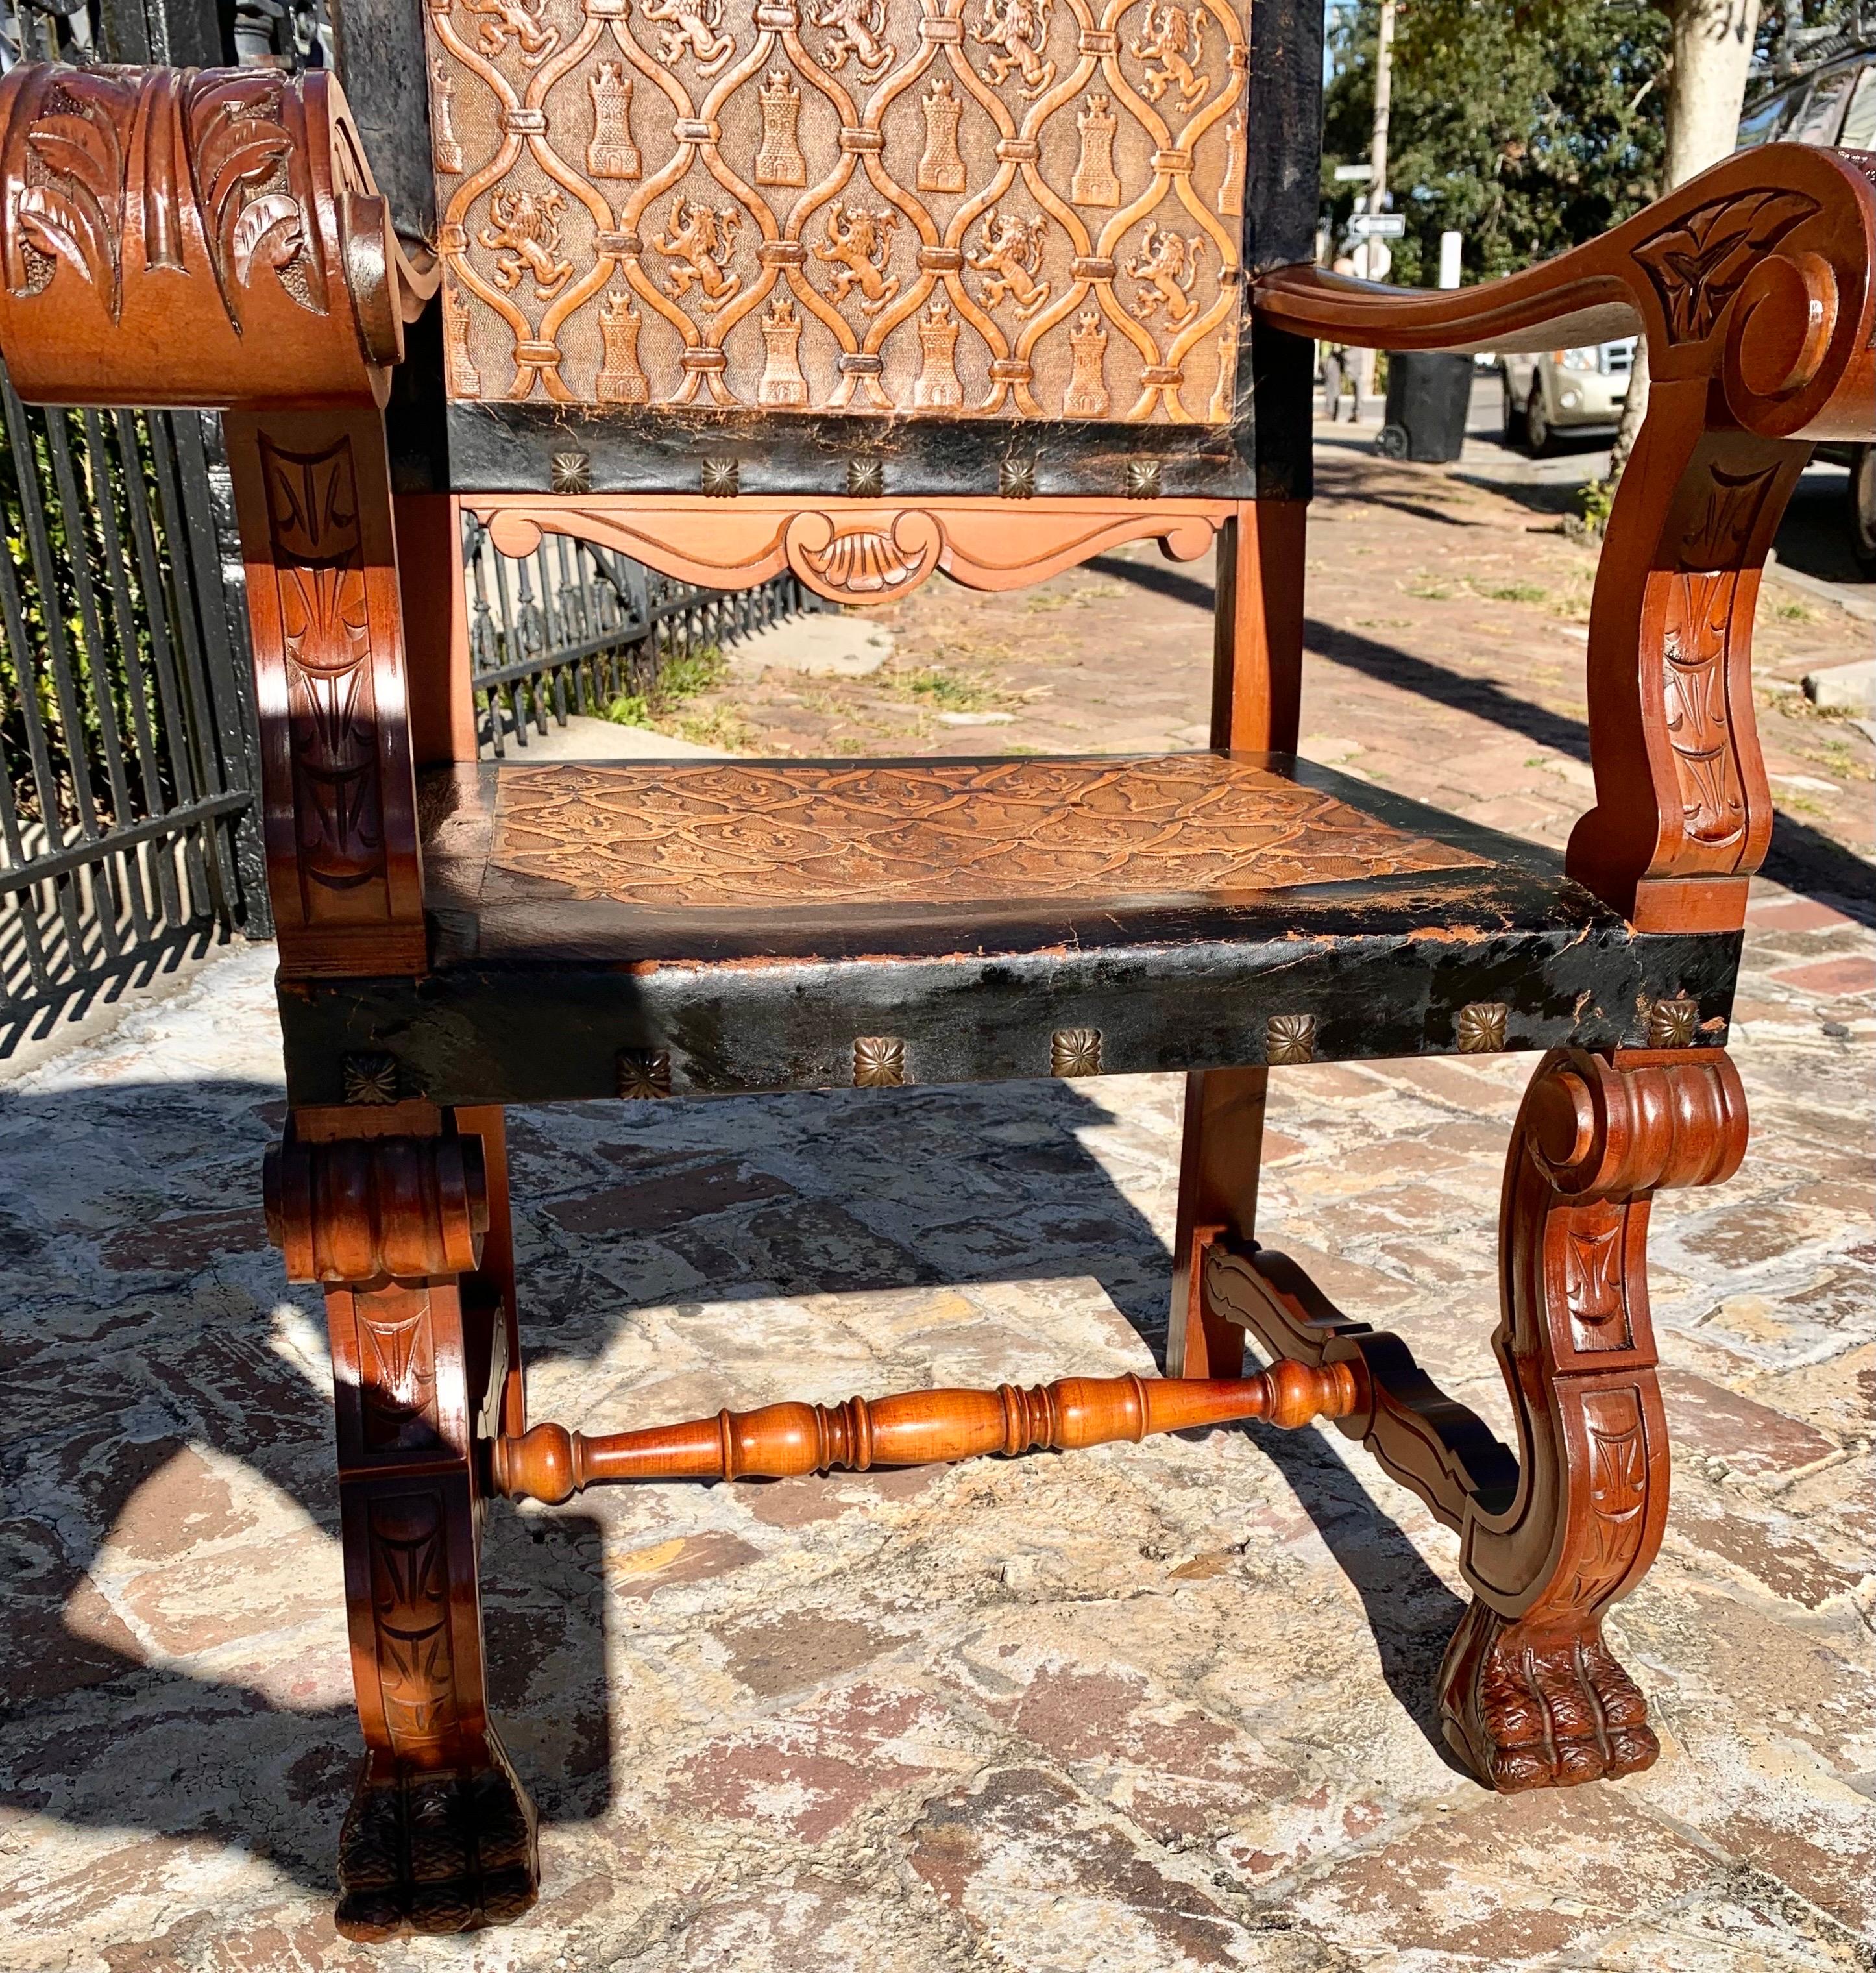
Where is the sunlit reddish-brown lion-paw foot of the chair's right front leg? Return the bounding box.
[1440,1602,1661,1795]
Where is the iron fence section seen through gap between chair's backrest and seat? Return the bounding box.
[461,515,821,757]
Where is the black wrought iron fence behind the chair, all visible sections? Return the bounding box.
[0,0,821,1053]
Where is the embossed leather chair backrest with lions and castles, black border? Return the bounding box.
[343,0,1320,493]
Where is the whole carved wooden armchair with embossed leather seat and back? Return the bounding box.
[0,11,1876,1937]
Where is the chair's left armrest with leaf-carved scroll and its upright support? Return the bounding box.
[0,63,436,979]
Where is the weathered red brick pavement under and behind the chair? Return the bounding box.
[0,424,1876,1973]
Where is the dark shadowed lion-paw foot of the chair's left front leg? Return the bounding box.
[334,1736,541,1941]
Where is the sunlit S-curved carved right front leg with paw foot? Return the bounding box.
[1440,1049,1746,1791]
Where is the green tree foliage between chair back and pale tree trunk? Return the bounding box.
[1324,0,1667,286]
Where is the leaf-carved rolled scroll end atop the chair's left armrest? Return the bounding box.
[0,63,436,410]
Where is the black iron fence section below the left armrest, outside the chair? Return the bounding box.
[0,379,266,1022]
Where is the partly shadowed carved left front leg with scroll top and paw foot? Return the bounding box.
[266,1113,539,1939]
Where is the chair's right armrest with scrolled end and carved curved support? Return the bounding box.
[1254,144,1876,931]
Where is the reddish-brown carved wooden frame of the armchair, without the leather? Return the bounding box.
[0,46,1876,1937]
